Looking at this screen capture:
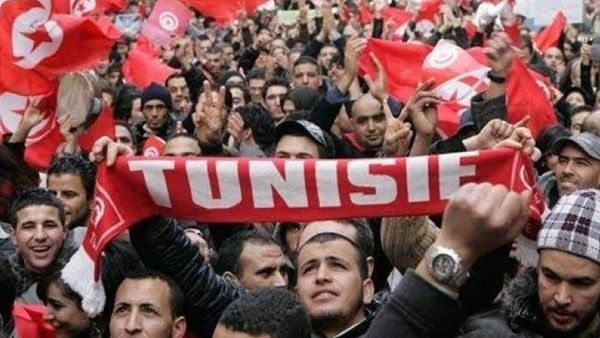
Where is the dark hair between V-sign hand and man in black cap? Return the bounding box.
[240,101,276,149]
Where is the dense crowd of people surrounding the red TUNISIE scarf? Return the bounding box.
[0,0,600,338]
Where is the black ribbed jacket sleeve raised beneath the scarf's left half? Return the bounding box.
[130,217,245,337]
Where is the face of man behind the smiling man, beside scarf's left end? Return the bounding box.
[48,174,90,227]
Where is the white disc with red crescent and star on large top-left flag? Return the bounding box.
[8,0,64,69]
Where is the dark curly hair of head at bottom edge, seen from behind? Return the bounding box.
[219,288,311,338]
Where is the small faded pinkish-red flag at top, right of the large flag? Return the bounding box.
[142,0,191,48]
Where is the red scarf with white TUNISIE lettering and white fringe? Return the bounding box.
[62,149,543,315]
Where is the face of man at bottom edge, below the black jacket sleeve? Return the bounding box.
[110,278,185,338]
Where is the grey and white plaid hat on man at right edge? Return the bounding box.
[538,189,600,264]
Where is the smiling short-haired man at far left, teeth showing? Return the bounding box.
[10,189,74,303]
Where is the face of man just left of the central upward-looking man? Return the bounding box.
[238,241,288,290]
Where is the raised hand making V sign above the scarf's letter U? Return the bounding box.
[192,81,225,144]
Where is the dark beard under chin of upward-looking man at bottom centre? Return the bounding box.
[311,289,363,332]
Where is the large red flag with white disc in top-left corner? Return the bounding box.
[0,0,120,95]
